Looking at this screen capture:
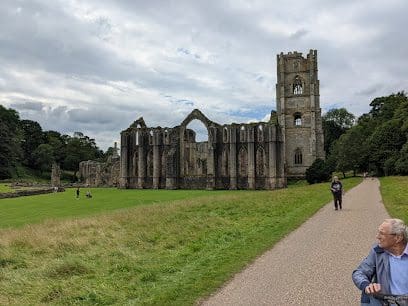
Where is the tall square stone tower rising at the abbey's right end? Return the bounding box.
[276,50,324,178]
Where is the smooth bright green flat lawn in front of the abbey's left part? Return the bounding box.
[0,188,236,228]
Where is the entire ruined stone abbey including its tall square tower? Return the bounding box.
[78,50,324,189]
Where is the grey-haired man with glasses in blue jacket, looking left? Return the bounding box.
[352,219,408,305]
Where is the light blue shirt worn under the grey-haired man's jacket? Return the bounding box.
[389,243,408,295]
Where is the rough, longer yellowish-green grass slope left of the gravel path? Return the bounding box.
[0,178,361,305]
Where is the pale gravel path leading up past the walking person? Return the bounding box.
[202,179,389,306]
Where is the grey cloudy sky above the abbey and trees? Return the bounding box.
[0,0,408,150]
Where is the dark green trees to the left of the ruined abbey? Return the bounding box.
[0,105,113,179]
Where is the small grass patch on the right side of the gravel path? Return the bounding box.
[380,176,408,224]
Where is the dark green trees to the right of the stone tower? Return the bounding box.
[306,91,408,183]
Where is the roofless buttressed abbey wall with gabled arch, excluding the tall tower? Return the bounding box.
[120,109,286,189]
